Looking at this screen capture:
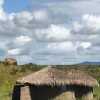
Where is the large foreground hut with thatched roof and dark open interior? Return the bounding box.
[12,67,98,100]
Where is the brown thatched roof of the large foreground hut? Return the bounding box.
[17,67,98,87]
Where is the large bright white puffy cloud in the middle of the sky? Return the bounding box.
[36,24,71,41]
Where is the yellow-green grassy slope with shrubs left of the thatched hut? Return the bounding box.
[0,63,42,100]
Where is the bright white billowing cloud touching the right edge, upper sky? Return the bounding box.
[72,14,100,34]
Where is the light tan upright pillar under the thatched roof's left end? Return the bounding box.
[20,86,31,100]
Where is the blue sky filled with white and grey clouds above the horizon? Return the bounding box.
[0,0,100,64]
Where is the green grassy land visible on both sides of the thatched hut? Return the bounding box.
[0,63,100,100]
